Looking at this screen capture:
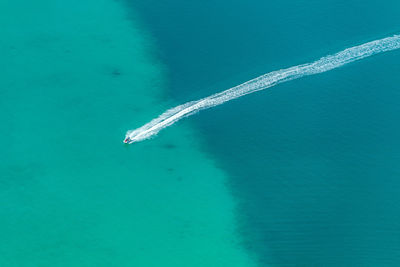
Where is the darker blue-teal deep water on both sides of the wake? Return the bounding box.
[129,0,400,266]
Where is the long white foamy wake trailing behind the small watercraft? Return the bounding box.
[126,35,400,143]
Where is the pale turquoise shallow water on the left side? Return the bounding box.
[0,0,253,267]
